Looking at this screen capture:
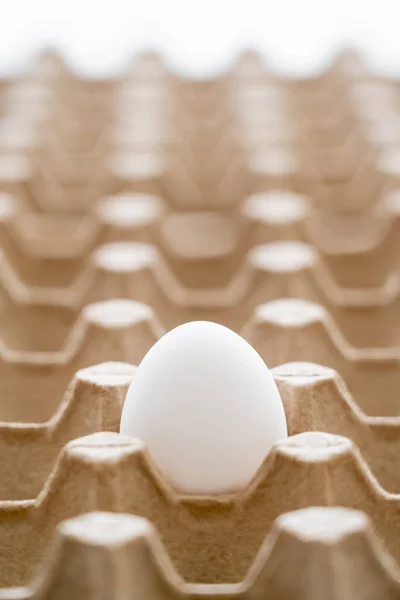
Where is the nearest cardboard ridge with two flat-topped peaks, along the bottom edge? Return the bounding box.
[0,507,400,600]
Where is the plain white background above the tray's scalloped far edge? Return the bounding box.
[0,0,400,76]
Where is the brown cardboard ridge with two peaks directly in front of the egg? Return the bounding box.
[0,432,400,587]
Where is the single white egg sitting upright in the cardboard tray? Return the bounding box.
[120,321,287,495]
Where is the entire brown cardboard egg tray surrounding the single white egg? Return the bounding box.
[0,45,400,600]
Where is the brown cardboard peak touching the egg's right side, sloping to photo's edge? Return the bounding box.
[272,362,400,494]
